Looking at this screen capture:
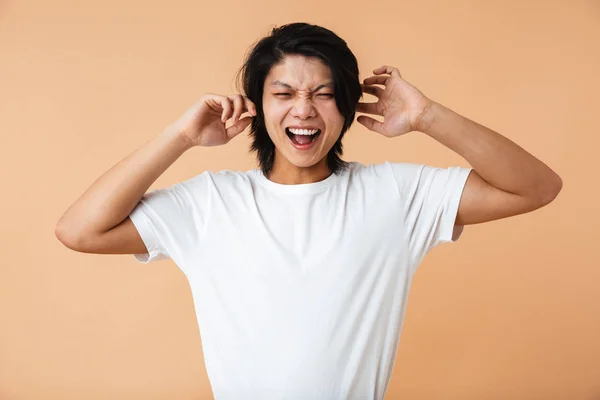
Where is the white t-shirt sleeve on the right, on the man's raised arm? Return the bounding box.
[390,163,472,268]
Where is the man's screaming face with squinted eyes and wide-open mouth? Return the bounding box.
[263,55,344,167]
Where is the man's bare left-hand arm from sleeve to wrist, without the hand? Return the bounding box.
[55,128,192,254]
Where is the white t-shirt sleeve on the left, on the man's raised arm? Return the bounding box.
[129,173,209,264]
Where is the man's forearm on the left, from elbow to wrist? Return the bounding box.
[56,128,190,240]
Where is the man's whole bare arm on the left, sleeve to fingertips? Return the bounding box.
[55,93,256,254]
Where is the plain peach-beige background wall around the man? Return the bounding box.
[0,0,600,400]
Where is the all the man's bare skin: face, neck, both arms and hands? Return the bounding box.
[56,56,562,254]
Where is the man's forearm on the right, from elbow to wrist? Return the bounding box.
[418,102,562,198]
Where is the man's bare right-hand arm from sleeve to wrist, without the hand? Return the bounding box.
[416,102,562,225]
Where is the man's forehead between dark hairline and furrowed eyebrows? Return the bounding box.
[265,55,333,90]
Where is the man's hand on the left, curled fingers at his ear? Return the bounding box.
[171,93,256,147]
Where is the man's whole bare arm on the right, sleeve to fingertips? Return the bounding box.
[356,65,562,226]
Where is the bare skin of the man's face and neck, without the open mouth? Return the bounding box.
[262,55,344,185]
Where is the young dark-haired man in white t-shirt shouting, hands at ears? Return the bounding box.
[56,24,562,399]
